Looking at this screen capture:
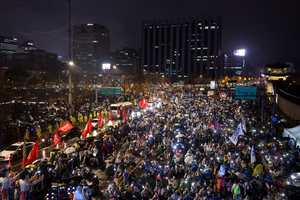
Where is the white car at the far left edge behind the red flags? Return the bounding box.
[0,142,34,160]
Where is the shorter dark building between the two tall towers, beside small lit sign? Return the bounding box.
[110,47,140,75]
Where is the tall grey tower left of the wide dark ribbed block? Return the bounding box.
[73,23,110,74]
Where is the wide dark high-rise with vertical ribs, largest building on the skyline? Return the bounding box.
[141,16,222,78]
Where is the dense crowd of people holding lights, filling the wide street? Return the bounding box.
[0,87,300,200]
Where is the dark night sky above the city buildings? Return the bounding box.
[0,0,300,65]
